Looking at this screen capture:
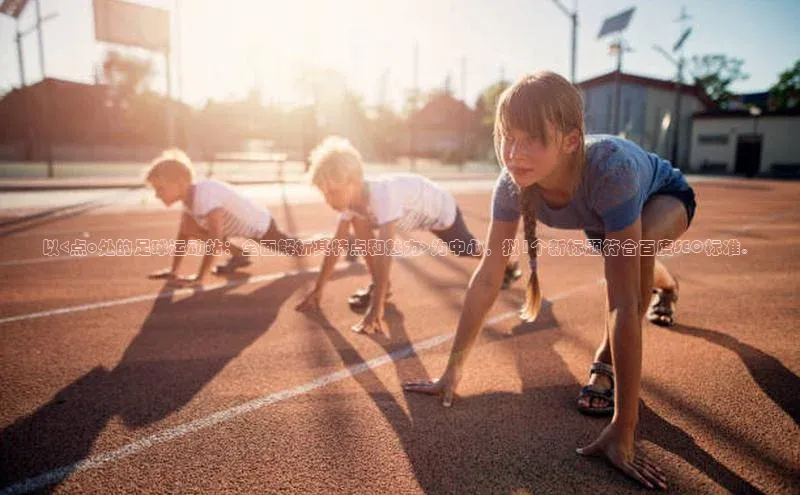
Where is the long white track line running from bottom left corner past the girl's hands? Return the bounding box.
[0,279,604,495]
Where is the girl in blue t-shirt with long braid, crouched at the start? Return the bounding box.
[404,72,695,488]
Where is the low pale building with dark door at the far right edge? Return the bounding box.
[689,107,800,177]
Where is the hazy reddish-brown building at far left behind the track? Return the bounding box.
[0,78,191,161]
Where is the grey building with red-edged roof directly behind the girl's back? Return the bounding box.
[578,71,714,168]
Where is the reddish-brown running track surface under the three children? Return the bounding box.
[0,179,800,493]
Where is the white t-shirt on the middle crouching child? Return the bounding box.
[339,174,456,232]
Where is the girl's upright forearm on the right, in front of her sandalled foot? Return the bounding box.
[609,307,642,428]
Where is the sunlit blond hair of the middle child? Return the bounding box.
[310,136,364,187]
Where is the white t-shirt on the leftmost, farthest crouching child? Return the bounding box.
[186,179,272,239]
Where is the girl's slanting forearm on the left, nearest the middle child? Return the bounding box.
[447,266,502,371]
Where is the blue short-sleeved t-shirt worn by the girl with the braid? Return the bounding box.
[492,135,689,233]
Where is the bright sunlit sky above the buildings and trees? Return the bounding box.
[0,0,800,109]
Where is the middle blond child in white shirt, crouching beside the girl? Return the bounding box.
[297,137,522,332]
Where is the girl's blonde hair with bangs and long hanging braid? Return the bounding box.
[494,71,585,321]
